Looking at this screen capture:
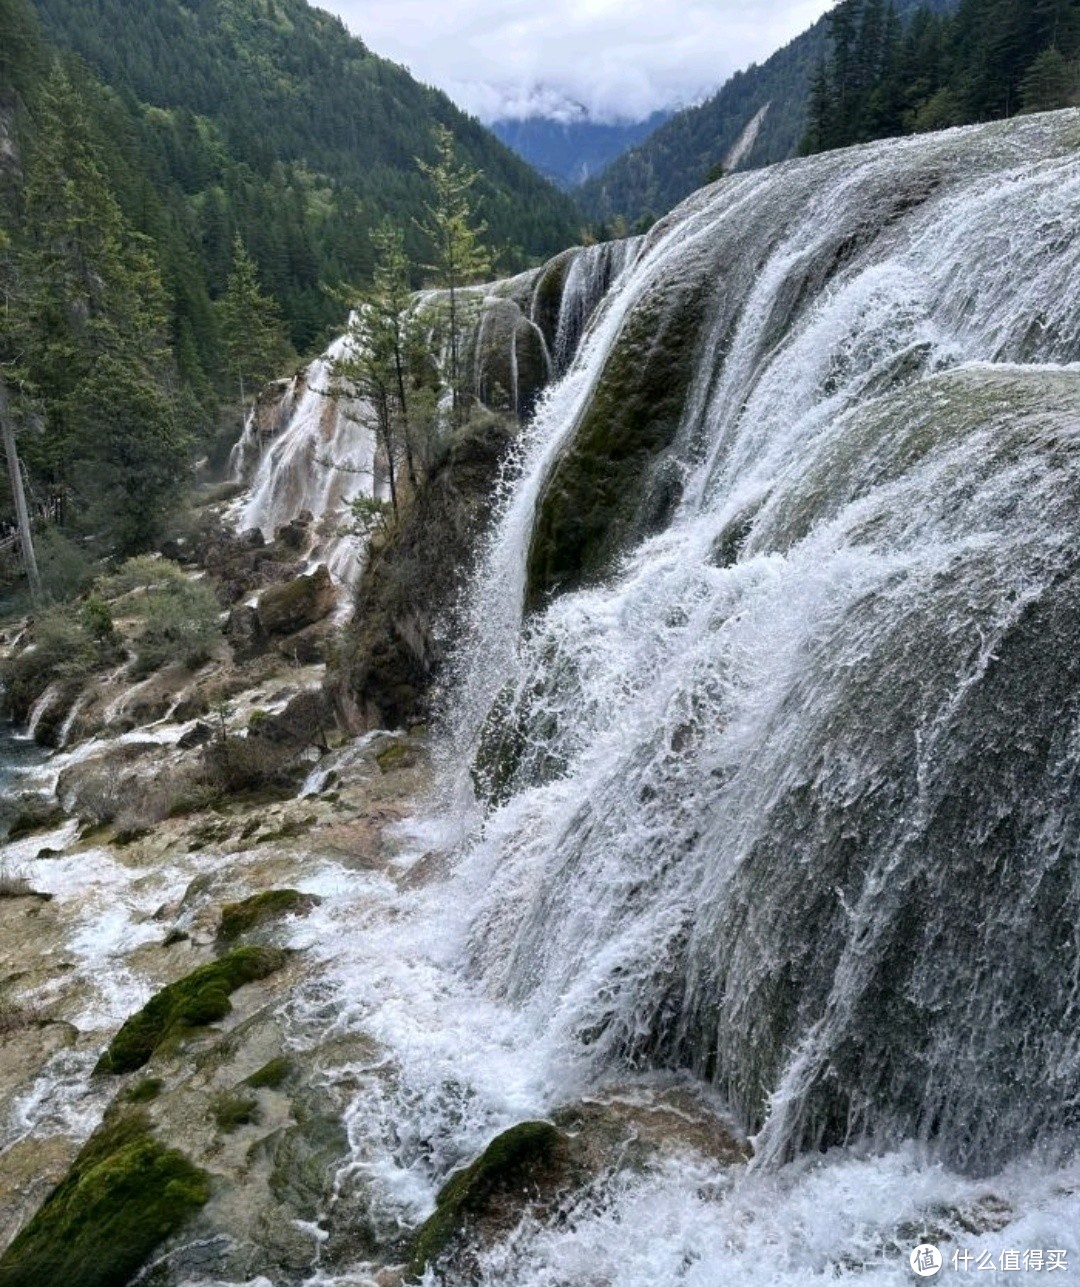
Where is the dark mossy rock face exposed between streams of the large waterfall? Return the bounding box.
[525,265,713,611]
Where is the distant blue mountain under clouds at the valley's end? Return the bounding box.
[492,112,671,189]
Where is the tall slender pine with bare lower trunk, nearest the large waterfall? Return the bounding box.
[417,125,492,425]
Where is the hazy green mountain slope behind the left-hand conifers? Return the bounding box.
[27,0,577,350]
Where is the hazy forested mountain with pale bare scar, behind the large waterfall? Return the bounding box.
[577,0,954,224]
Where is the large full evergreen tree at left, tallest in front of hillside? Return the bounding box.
[22,66,189,551]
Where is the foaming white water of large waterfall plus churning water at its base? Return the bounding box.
[302,113,1080,1287]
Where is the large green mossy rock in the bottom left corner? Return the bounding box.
[0,1113,210,1287]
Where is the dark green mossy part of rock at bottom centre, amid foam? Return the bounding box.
[409,1122,572,1279]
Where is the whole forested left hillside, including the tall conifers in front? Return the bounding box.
[0,0,578,568]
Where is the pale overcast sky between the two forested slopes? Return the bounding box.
[315,0,830,121]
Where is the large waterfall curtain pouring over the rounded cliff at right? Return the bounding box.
[440,112,1080,1174]
